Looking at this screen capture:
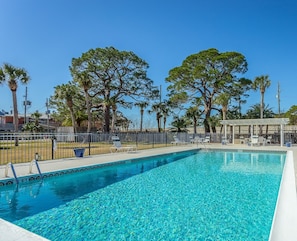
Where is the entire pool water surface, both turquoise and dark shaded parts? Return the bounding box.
[0,151,285,240]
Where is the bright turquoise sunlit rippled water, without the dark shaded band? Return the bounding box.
[11,152,282,241]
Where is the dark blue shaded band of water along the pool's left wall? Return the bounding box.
[0,152,195,221]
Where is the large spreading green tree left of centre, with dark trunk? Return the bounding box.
[70,47,155,132]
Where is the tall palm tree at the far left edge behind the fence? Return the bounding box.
[0,63,30,146]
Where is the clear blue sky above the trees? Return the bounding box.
[0,0,297,128]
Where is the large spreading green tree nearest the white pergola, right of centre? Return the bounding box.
[166,48,247,132]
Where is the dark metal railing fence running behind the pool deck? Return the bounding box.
[0,132,297,165]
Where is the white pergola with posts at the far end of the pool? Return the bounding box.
[220,118,289,146]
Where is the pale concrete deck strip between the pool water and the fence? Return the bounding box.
[0,143,297,181]
